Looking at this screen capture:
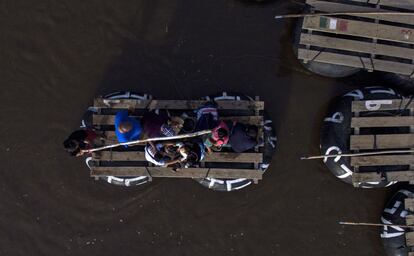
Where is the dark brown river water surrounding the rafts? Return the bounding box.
[0,0,394,256]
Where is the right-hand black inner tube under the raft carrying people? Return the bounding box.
[195,92,277,191]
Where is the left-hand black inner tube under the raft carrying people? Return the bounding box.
[81,91,151,187]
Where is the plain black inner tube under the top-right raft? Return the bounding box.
[293,17,361,78]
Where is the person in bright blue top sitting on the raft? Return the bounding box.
[115,110,142,143]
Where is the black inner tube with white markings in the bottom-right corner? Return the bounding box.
[381,186,414,256]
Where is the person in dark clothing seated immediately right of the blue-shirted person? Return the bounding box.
[142,111,184,138]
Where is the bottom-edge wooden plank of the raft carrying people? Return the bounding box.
[91,167,263,180]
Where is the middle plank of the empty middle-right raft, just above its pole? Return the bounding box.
[350,134,414,150]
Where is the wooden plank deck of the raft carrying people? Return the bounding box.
[90,95,264,183]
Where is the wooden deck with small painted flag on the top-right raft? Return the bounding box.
[298,0,414,78]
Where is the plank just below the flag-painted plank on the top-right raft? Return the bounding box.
[300,33,414,59]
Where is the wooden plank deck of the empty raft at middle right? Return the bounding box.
[350,99,414,186]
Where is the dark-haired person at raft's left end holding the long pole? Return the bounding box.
[63,128,104,156]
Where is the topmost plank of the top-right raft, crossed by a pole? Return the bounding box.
[306,0,414,25]
